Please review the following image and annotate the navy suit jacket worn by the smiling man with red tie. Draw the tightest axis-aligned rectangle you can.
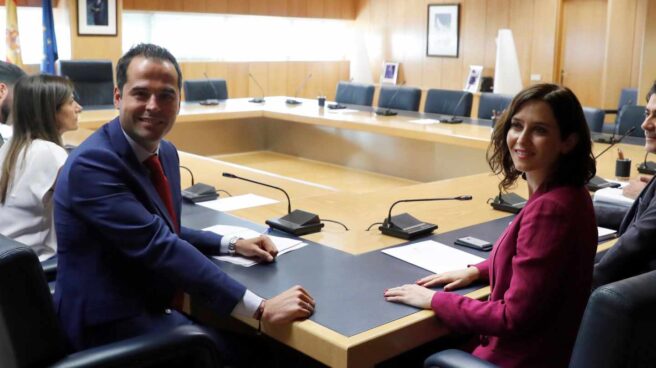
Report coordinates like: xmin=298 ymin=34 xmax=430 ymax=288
xmin=54 ymin=118 xmax=246 ymax=349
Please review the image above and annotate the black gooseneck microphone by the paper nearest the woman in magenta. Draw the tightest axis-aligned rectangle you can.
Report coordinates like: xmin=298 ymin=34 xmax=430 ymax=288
xmin=378 ymin=195 xmax=472 ymax=240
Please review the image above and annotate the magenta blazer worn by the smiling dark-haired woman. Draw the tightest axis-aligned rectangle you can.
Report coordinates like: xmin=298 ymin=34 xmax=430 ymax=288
xmin=431 ymin=186 xmax=597 ymax=367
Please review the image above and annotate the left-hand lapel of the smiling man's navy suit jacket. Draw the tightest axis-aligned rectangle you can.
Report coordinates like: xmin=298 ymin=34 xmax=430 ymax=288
xmin=108 ymin=118 xmax=176 ymax=231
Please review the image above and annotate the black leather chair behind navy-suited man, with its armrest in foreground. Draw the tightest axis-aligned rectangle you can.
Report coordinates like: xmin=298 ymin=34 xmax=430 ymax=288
xmin=0 ymin=235 xmax=221 ymax=368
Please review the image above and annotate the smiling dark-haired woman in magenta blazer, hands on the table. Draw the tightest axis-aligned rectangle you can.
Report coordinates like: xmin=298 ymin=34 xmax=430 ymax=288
xmin=385 ymin=84 xmax=597 ymax=367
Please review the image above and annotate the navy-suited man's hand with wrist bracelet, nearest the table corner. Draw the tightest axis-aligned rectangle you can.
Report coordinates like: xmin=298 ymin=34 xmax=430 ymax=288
xmin=262 ymin=285 xmax=315 ymax=324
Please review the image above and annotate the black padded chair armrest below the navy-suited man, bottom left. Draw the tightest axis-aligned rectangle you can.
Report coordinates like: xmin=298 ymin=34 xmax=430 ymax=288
xmin=52 ymin=325 xmax=221 ymax=368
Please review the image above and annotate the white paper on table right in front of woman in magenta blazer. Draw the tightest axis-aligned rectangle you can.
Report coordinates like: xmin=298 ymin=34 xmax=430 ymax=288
xmin=381 ymin=240 xmax=485 ymax=273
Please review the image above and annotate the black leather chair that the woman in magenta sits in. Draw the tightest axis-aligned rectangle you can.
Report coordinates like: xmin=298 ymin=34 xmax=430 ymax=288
xmin=424 ymin=271 xmax=656 ymax=368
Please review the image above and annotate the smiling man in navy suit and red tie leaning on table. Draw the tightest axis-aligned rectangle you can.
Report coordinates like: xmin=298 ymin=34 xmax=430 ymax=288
xmin=55 ymin=44 xmax=314 ymax=356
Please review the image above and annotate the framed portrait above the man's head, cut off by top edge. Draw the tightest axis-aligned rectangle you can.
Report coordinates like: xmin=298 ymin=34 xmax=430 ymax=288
xmin=77 ymin=0 xmax=117 ymax=36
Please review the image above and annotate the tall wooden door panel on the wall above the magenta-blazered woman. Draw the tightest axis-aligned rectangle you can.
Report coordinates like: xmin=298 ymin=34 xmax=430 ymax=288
xmin=560 ymin=0 xmax=608 ymax=107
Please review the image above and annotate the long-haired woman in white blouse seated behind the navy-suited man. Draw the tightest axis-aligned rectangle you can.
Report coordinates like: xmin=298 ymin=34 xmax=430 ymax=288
xmin=0 ymin=75 xmax=82 ymax=261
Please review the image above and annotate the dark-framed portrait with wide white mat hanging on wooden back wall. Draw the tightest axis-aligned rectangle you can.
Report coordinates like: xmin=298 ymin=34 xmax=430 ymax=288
xmin=426 ymin=4 xmax=460 ymax=57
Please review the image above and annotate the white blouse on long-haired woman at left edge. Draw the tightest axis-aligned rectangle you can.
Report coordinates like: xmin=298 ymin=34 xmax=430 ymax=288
xmin=0 ymin=139 xmax=68 ymax=261
